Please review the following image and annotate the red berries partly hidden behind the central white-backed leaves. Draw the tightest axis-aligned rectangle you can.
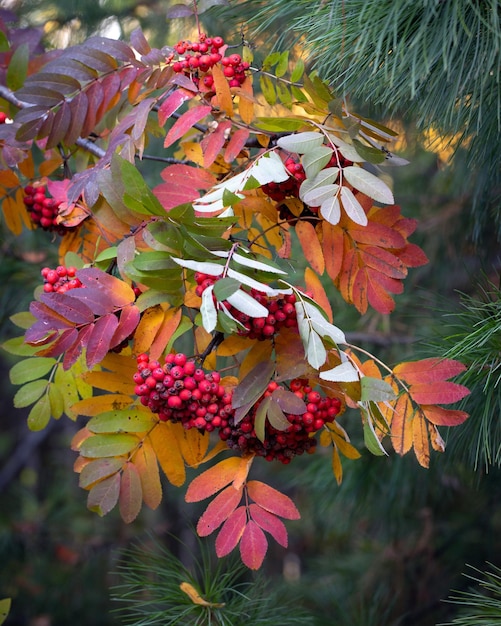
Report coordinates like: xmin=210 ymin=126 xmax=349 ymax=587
xmin=195 ymin=272 xmax=297 ymax=340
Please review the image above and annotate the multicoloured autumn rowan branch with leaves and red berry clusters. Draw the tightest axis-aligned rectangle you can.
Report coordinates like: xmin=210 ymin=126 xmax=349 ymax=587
xmin=0 ymin=9 xmax=468 ymax=569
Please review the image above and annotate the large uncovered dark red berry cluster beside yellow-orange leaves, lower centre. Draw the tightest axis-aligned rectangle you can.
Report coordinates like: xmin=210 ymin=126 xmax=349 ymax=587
xmin=134 ymin=352 xmax=233 ymax=432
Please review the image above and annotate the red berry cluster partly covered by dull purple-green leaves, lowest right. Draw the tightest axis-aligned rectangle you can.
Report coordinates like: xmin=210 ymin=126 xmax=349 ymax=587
xmin=219 ymin=379 xmax=341 ymax=464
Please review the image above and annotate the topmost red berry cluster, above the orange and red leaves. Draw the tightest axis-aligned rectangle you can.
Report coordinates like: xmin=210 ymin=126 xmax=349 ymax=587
xmin=170 ymin=33 xmax=250 ymax=89
